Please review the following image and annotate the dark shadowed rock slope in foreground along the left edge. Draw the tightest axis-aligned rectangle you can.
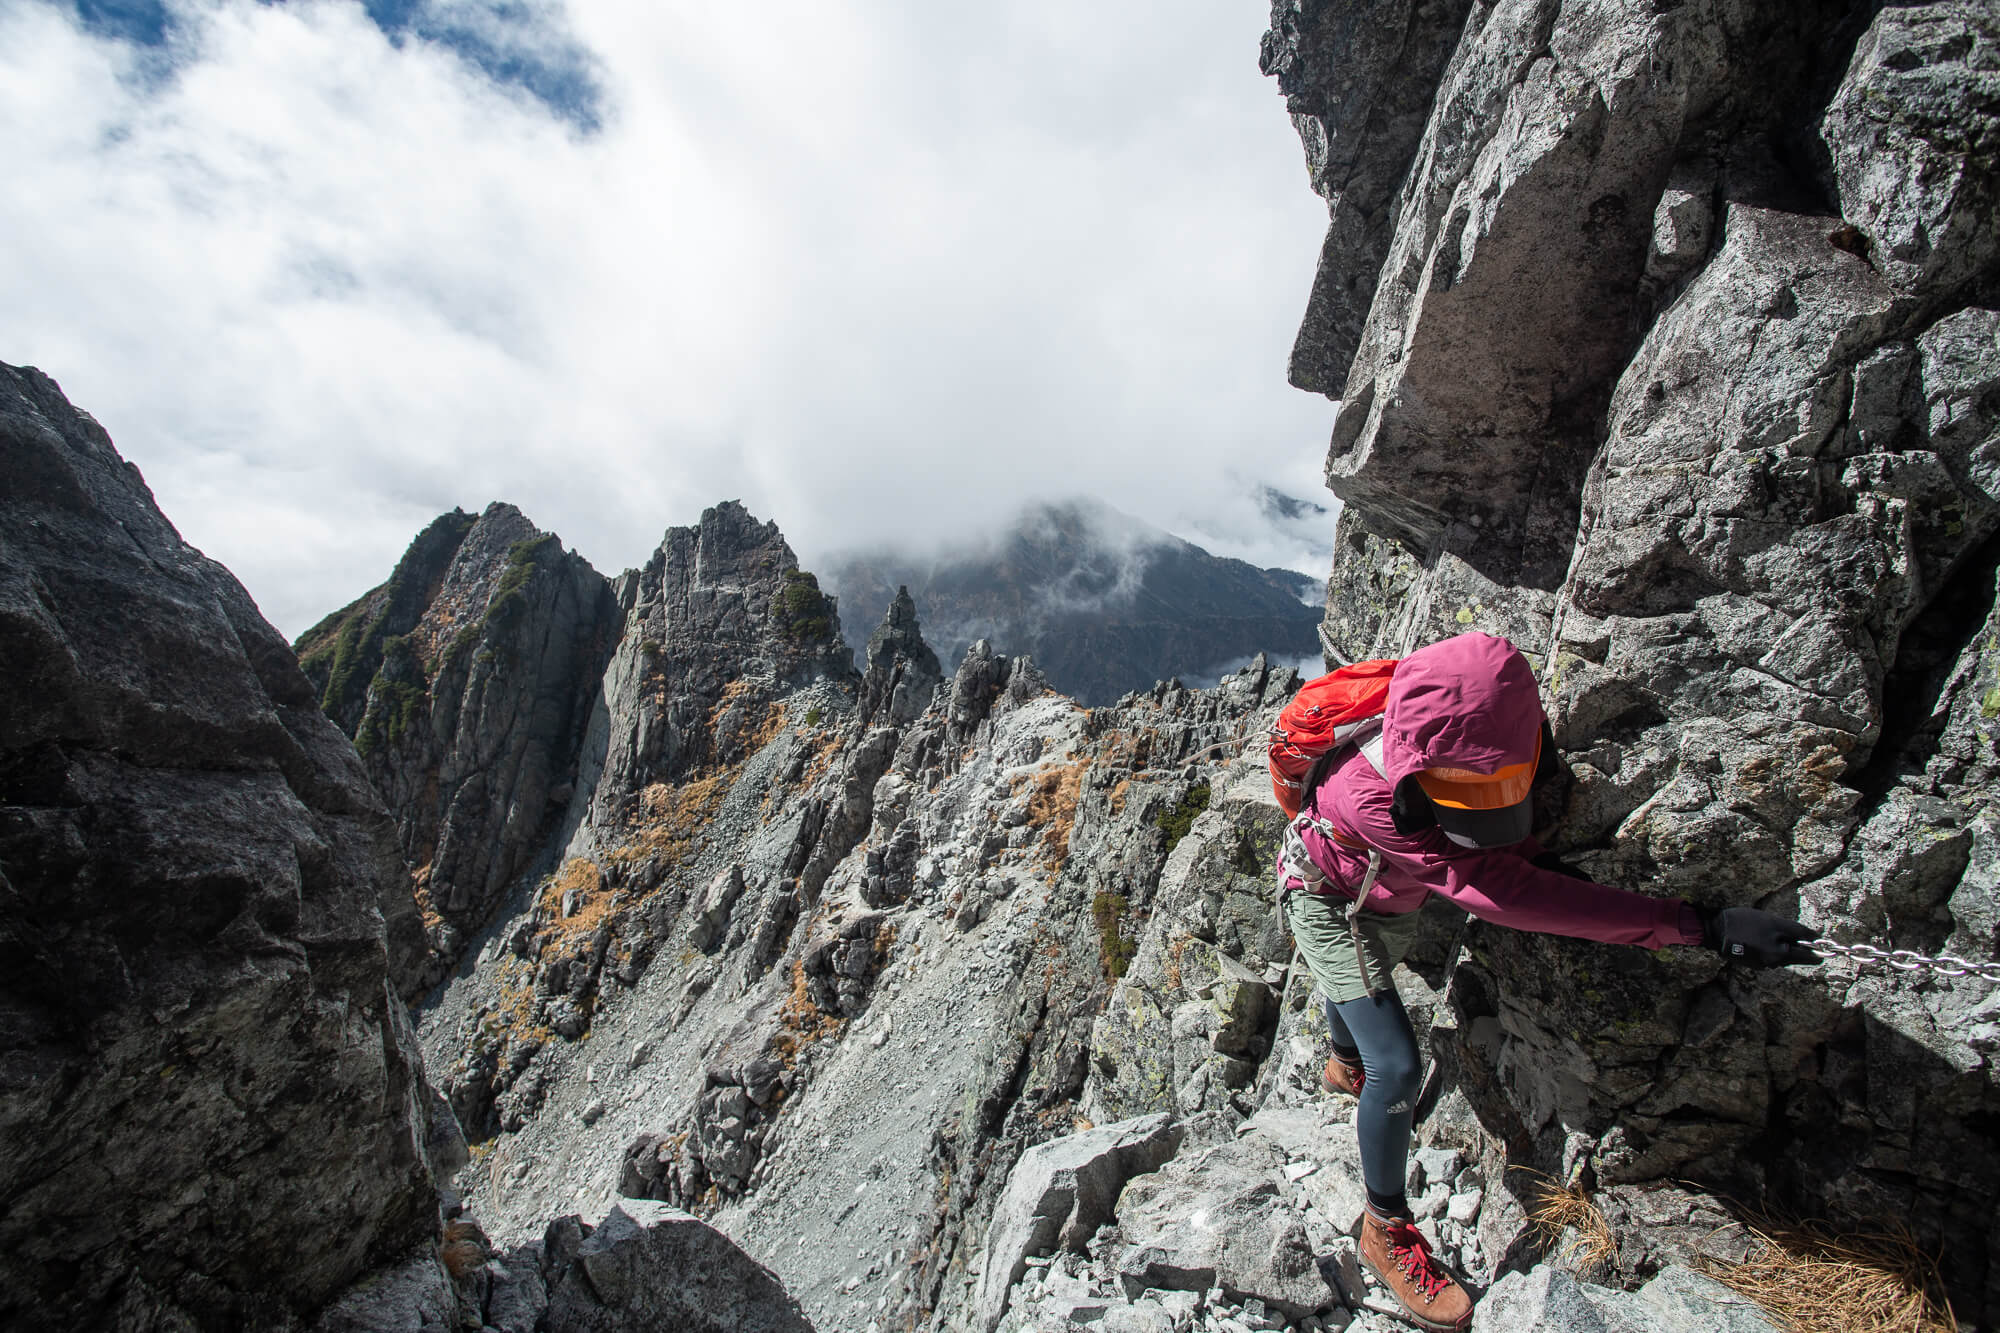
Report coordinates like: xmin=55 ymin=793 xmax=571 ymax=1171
xmin=0 ymin=366 xmax=438 ymax=1329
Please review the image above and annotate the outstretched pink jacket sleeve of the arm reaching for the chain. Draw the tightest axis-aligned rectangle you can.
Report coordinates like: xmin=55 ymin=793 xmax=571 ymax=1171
xmin=1348 ymin=756 xmax=1702 ymax=949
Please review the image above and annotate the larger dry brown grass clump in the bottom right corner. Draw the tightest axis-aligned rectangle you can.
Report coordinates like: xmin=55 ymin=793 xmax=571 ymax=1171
xmin=1702 ymin=1223 xmax=1958 ymax=1333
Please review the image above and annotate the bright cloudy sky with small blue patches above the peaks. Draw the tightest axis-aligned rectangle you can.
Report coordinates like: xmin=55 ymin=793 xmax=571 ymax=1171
xmin=0 ymin=0 xmax=1332 ymax=634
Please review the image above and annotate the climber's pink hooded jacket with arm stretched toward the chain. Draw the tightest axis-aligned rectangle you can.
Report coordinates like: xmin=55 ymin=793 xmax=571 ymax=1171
xmin=1288 ymin=634 xmax=1702 ymax=949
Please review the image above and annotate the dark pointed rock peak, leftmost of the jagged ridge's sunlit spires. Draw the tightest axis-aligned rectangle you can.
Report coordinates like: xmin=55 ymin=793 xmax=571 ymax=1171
xmin=296 ymin=504 xmax=620 ymax=981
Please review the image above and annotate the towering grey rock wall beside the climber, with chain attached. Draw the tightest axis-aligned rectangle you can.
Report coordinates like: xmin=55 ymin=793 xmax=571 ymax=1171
xmin=1264 ymin=0 xmax=2000 ymax=1313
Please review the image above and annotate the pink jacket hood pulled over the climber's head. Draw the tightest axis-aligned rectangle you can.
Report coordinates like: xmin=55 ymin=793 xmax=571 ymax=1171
xmin=1382 ymin=632 xmax=1542 ymax=787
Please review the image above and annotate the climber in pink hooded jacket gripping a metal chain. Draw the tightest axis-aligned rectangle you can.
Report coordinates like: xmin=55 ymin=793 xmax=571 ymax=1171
xmin=1278 ymin=634 xmax=1818 ymax=1331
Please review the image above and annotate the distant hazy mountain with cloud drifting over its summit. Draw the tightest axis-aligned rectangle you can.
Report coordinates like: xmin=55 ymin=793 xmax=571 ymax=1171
xmin=822 ymin=500 xmax=1320 ymax=705
